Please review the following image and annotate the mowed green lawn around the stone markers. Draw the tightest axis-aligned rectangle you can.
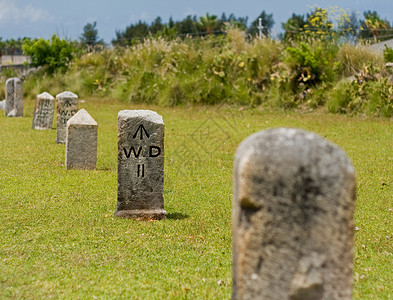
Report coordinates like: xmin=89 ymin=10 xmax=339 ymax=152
xmin=0 ymin=99 xmax=393 ymax=299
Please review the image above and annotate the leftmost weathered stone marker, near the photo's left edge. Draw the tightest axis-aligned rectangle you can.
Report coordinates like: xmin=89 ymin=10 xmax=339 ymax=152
xmin=5 ymin=78 xmax=23 ymax=117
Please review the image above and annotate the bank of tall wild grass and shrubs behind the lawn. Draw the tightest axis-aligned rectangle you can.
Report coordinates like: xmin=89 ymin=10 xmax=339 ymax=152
xmin=0 ymin=29 xmax=392 ymax=116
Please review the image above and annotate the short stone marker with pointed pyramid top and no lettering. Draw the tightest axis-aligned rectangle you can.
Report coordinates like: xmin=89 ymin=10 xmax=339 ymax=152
xmin=65 ymin=109 xmax=97 ymax=170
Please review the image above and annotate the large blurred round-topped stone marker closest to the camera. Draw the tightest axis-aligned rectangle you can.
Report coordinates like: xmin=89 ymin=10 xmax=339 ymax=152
xmin=232 ymin=128 xmax=356 ymax=300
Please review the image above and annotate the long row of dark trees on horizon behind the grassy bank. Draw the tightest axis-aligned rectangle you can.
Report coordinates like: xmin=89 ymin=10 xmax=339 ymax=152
xmin=112 ymin=7 xmax=393 ymax=46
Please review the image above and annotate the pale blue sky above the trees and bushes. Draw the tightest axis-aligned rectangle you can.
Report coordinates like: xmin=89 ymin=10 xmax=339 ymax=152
xmin=0 ymin=0 xmax=393 ymax=43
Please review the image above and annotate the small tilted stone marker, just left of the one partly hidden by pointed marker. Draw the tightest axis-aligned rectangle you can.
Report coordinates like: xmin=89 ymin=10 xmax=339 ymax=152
xmin=33 ymin=92 xmax=55 ymax=130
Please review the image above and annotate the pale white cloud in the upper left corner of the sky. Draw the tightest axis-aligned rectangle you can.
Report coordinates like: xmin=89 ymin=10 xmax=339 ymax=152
xmin=0 ymin=0 xmax=53 ymax=23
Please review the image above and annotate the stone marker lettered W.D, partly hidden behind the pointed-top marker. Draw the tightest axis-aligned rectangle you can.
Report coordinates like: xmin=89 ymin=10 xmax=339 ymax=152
xmin=56 ymin=92 xmax=78 ymax=144
